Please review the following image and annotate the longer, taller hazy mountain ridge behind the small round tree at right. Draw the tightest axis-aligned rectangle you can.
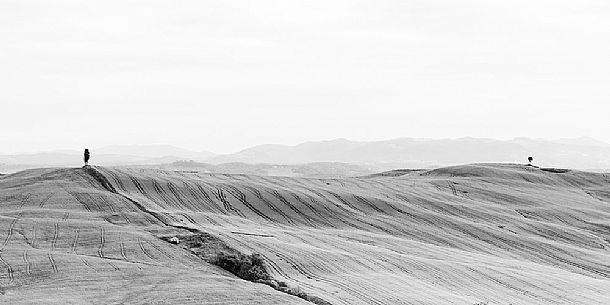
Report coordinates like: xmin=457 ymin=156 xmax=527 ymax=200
xmin=207 ymin=138 xmax=610 ymax=169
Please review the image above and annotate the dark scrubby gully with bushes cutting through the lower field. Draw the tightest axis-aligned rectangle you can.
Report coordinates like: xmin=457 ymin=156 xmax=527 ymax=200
xmin=159 ymin=232 xmax=332 ymax=305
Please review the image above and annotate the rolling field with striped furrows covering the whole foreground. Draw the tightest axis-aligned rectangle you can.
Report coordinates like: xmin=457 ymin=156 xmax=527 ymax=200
xmin=0 ymin=164 xmax=610 ymax=305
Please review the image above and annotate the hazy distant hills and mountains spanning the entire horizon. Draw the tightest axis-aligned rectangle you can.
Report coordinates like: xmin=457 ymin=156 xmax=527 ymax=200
xmin=0 ymin=137 xmax=610 ymax=172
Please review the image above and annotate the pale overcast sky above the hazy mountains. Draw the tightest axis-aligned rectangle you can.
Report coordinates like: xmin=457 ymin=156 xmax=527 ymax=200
xmin=0 ymin=0 xmax=610 ymax=153
